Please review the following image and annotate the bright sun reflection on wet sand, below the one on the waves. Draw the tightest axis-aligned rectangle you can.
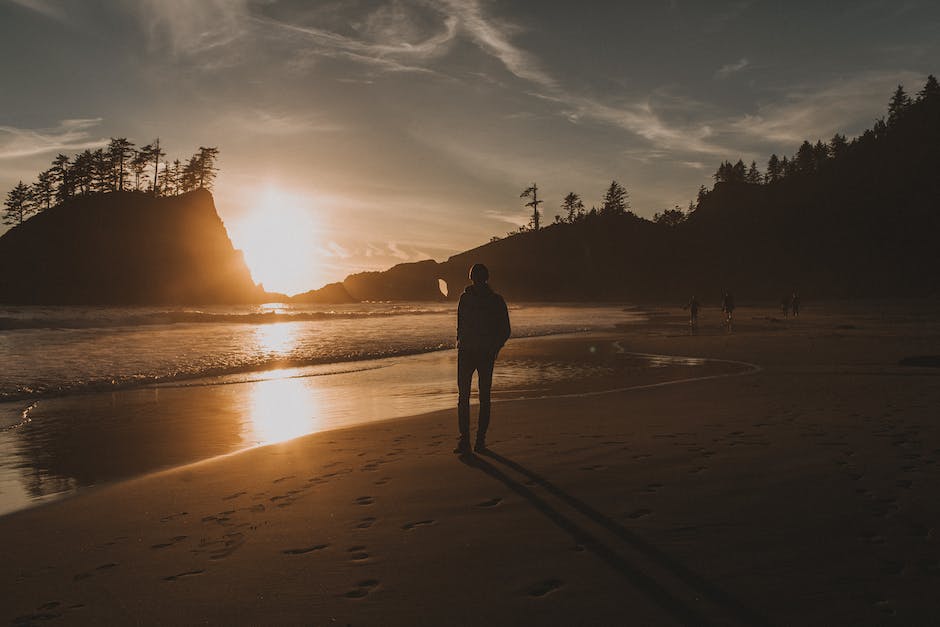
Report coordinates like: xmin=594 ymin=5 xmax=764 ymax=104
xmin=245 ymin=372 xmax=320 ymax=444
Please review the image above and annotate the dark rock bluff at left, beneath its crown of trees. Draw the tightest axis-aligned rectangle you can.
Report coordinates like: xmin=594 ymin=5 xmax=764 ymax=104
xmin=0 ymin=190 xmax=264 ymax=305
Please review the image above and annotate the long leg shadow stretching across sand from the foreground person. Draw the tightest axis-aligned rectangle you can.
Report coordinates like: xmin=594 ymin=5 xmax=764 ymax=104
xmin=460 ymin=450 xmax=771 ymax=625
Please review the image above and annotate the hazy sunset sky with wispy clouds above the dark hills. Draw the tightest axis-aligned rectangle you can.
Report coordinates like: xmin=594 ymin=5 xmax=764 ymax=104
xmin=0 ymin=0 xmax=940 ymax=293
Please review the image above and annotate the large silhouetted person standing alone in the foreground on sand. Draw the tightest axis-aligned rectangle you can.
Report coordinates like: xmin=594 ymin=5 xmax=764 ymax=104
xmin=454 ymin=263 xmax=511 ymax=454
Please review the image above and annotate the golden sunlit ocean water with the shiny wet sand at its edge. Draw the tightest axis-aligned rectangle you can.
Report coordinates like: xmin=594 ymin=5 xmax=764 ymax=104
xmin=0 ymin=303 xmax=644 ymax=514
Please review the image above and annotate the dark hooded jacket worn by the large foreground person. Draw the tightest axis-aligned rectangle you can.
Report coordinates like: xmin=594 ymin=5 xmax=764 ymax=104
xmin=457 ymin=285 xmax=512 ymax=358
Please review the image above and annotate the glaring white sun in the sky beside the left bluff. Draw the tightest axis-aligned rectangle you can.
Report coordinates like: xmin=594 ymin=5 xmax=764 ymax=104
xmin=229 ymin=186 xmax=322 ymax=294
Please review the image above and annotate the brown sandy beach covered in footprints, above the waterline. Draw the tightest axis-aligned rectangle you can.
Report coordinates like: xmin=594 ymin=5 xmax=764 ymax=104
xmin=0 ymin=303 xmax=940 ymax=625
